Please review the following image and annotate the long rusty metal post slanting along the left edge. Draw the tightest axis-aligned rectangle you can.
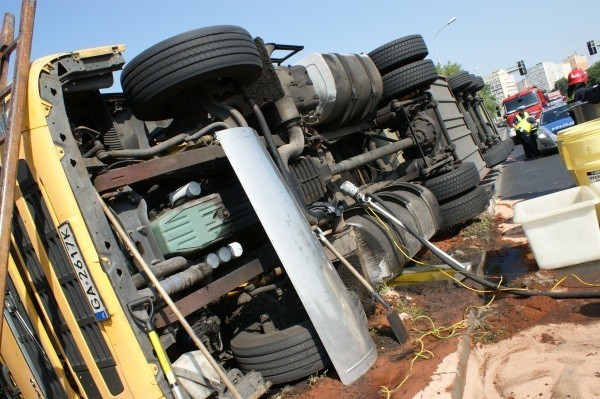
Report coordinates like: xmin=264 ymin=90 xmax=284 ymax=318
xmin=0 ymin=0 xmax=36 ymax=340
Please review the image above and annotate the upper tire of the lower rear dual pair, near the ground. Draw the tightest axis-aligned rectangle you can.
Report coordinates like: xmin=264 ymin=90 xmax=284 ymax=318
xmin=423 ymin=162 xmax=481 ymax=202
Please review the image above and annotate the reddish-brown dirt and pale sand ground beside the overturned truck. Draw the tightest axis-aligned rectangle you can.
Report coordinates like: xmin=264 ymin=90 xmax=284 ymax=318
xmin=268 ymin=201 xmax=600 ymax=399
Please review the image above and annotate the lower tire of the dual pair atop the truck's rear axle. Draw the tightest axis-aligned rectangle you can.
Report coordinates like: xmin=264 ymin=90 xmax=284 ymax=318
xmin=382 ymin=60 xmax=439 ymax=104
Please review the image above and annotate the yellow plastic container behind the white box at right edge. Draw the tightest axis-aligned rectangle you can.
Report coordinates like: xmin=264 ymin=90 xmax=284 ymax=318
xmin=557 ymin=119 xmax=600 ymax=219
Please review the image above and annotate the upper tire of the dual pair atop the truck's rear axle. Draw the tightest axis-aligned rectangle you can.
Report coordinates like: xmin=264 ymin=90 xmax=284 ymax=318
xmin=367 ymin=35 xmax=429 ymax=75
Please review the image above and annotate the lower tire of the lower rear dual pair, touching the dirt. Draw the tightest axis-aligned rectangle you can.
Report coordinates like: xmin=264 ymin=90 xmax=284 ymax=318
xmin=440 ymin=186 xmax=490 ymax=230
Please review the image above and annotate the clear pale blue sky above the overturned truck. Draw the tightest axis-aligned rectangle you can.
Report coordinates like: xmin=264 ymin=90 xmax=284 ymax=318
xmin=0 ymin=0 xmax=600 ymax=87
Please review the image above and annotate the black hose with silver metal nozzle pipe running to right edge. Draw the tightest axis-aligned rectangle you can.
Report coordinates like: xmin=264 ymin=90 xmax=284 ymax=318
xmin=341 ymin=182 xmax=600 ymax=299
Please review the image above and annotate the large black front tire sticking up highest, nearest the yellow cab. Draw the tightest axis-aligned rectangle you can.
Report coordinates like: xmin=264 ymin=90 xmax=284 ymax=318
xmin=121 ymin=25 xmax=262 ymax=120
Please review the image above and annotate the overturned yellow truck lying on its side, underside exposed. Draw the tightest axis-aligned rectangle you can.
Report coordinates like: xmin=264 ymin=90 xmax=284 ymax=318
xmin=0 ymin=10 xmax=502 ymax=398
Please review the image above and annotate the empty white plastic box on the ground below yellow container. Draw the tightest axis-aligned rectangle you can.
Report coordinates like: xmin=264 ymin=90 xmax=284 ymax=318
xmin=513 ymin=186 xmax=600 ymax=269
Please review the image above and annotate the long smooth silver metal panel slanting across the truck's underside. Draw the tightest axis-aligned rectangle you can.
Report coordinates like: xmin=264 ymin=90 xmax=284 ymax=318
xmin=217 ymin=128 xmax=377 ymax=385
